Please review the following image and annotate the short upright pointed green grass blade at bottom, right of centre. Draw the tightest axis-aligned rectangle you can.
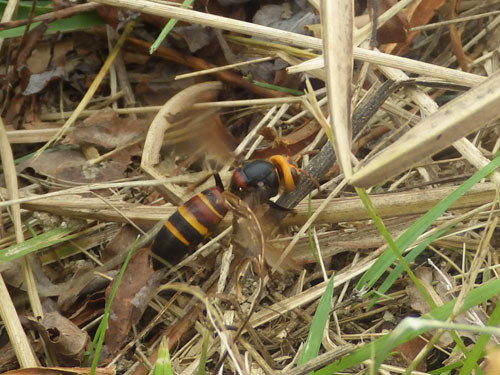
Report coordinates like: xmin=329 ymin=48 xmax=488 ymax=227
xmin=297 ymin=275 xmax=334 ymax=365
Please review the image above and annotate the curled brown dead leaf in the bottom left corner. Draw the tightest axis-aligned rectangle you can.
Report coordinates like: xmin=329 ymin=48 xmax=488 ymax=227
xmin=25 ymin=311 xmax=90 ymax=365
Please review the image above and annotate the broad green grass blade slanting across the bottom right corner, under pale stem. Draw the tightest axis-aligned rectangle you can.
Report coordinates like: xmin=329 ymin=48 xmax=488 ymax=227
xmin=315 ymin=279 xmax=500 ymax=375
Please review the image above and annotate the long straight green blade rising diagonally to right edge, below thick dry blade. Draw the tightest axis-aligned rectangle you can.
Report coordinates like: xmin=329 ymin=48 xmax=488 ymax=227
xmin=356 ymin=151 xmax=500 ymax=289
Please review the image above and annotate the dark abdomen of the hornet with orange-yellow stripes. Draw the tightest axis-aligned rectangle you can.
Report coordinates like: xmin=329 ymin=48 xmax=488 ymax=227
xmin=152 ymin=187 xmax=227 ymax=268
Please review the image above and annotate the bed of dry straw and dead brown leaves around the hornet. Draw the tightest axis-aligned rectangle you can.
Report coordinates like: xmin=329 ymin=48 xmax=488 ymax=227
xmin=0 ymin=0 xmax=500 ymax=375
